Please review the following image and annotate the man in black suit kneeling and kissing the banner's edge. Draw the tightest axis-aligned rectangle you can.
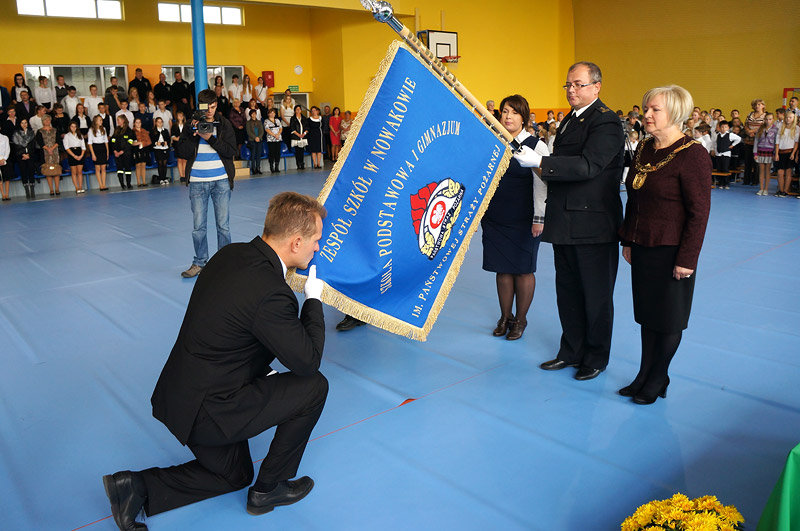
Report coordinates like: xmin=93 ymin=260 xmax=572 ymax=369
xmin=103 ymin=192 xmax=328 ymax=530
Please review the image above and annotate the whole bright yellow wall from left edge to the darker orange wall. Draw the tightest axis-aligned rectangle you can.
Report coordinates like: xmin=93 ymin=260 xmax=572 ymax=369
xmin=0 ymin=0 xmax=574 ymax=115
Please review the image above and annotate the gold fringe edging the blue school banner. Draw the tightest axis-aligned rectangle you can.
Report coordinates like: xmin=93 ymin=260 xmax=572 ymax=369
xmin=286 ymin=41 xmax=511 ymax=341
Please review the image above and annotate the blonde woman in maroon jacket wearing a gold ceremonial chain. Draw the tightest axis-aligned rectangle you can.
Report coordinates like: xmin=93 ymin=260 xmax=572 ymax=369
xmin=620 ymin=85 xmax=711 ymax=404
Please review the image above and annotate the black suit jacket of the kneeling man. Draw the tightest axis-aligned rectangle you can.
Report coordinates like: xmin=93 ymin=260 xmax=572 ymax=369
xmin=151 ymin=237 xmax=325 ymax=444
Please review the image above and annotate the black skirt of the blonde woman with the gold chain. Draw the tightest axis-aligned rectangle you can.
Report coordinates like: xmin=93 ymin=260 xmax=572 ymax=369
xmin=631 ymin=244 xmax=696 ymax=333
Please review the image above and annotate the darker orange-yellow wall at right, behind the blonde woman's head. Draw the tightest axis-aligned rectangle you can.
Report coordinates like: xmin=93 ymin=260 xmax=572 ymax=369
xmin=573 ymin=0 xmax=800 ymax=116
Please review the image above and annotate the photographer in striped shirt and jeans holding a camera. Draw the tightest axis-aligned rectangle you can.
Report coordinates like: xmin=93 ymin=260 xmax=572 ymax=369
xmin=181 ymin=89 xmax=236 ymax=278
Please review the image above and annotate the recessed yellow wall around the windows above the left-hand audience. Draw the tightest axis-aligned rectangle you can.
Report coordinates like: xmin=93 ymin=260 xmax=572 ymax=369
xmin=0 ymin=0 xmax=313 ymax=91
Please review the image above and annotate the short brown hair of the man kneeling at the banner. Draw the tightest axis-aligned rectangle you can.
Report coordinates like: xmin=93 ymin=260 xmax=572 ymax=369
xmin=264 ymin=192 xmax=328 ymax=238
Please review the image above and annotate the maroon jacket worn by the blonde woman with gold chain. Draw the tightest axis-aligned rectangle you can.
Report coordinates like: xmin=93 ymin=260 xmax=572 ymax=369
xmin=619 ymin=137 xmax=711 ymax=269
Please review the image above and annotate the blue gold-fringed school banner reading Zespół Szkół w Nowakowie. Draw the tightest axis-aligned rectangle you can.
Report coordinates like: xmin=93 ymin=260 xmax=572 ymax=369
xmin=288 ymin=41 xmax=511 ymax=341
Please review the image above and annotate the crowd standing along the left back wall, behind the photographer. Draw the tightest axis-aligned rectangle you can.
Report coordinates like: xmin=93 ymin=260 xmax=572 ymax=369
xmin=0 ymin=68 xmax=352 ymax=201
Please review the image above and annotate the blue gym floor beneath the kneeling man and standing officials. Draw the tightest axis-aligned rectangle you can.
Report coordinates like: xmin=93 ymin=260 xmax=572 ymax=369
xmin=0 ymin=171 xmax=800 ymax=531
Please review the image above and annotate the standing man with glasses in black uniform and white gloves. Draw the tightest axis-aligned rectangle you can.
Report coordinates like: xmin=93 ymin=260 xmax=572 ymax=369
xmin=515 ymin=62 xmax=624 ymax=380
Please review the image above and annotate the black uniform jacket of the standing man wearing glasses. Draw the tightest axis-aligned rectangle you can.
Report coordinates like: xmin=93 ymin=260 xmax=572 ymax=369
xmin=541 ymin=99 xmax=625 ymax=245
